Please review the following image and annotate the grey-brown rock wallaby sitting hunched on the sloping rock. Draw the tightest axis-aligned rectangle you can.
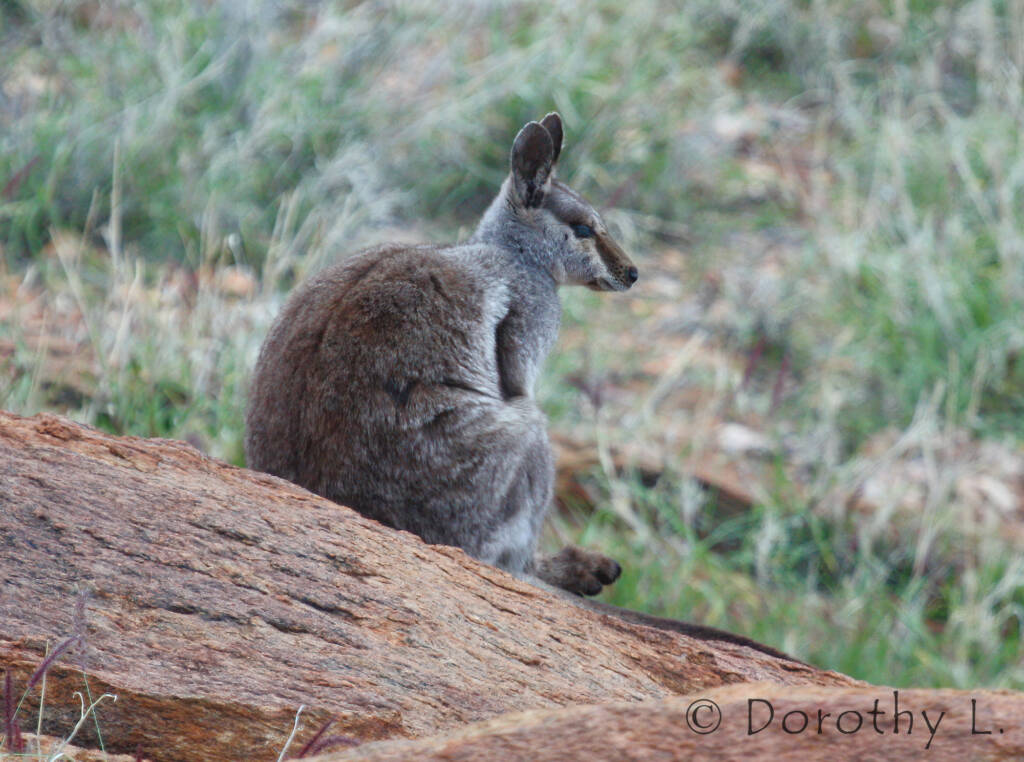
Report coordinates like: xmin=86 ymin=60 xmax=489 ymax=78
xmin=246 ymin=114 xmax=638 ymax=595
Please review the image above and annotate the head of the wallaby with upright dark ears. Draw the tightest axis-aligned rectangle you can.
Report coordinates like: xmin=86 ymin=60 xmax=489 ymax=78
xmin=474 ymin=113 xmax=639 ymax=291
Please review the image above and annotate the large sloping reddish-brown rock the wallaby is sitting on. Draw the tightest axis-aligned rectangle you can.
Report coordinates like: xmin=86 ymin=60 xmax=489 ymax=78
xmin=0 ymin=413 xmax=857 ymax=761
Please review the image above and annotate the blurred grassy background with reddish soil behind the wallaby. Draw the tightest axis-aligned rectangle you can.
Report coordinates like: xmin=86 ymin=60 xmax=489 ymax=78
xmin=0 ymin=0 xmax=1024 ymax=689
